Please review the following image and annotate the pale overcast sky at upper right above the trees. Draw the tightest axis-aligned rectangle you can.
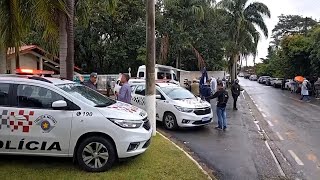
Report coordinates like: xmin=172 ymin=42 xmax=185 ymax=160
xmin=248 ymin=0 xmax=320 ymax=65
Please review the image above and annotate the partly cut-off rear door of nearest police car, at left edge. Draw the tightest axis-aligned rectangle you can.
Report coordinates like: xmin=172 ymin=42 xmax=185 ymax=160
xmin=0 ymin=83 xmax=12 ymax=152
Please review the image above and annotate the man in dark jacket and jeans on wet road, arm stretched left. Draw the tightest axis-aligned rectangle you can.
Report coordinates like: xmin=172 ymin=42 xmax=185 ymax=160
xmin=206 ymin=81 xmax=229 ymax=131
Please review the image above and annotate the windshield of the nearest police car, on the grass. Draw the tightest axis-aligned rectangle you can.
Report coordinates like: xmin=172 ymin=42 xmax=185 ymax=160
xmin=58 ymin=84 xmax=116 ymax=107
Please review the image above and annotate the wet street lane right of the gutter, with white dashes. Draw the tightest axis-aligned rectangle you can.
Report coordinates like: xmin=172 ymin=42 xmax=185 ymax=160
xmin=240 ymin=79 xmax=320 ymax=180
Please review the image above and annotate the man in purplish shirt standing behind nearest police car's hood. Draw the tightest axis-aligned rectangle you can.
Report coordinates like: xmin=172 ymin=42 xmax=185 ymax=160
xmin=117 ymin=74 xmax=131 ymax=104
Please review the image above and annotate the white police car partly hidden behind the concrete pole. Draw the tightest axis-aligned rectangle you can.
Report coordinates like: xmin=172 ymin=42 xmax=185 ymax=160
xmin=131 ymin=83 xmax=213 ymax=130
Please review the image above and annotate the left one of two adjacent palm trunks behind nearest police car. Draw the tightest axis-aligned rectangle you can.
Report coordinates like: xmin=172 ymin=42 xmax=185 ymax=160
xmin=59 ymin=12 xmax=68 ymax=78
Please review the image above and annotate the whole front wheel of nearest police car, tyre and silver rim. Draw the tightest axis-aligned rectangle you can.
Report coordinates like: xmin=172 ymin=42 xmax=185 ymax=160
xmin=77 ymin=136 xmax=116 ymax=172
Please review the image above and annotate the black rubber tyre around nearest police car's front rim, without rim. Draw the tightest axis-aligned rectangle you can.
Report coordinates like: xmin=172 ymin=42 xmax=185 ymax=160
xmin=77 ymin=136 xmax=116 ymax=172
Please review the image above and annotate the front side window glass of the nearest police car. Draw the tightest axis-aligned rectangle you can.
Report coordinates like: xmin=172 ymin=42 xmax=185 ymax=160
xmin=17 ymin=85 xmax=64 ymax=109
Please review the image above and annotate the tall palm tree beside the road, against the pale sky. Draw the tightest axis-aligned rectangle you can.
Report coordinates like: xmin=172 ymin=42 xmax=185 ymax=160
xmin=217 ymin=0 xmax=271 ymax=81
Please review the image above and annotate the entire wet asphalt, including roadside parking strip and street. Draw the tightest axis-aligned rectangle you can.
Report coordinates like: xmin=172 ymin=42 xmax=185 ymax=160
xmin=160 ymin=79 xmax=320 ymax=180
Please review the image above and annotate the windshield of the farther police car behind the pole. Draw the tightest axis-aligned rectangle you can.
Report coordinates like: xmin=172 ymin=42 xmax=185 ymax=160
xmin=161 ymin=87 xmax=196 ymax=100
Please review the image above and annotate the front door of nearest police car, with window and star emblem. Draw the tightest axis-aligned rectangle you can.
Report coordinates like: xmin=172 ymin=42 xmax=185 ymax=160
xmin=10 ymin=84 xmax=73 ymax=156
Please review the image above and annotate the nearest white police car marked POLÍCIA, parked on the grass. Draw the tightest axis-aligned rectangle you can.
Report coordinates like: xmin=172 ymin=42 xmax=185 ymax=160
xmin=0 ymin=70 xmax=152 ymax=172
